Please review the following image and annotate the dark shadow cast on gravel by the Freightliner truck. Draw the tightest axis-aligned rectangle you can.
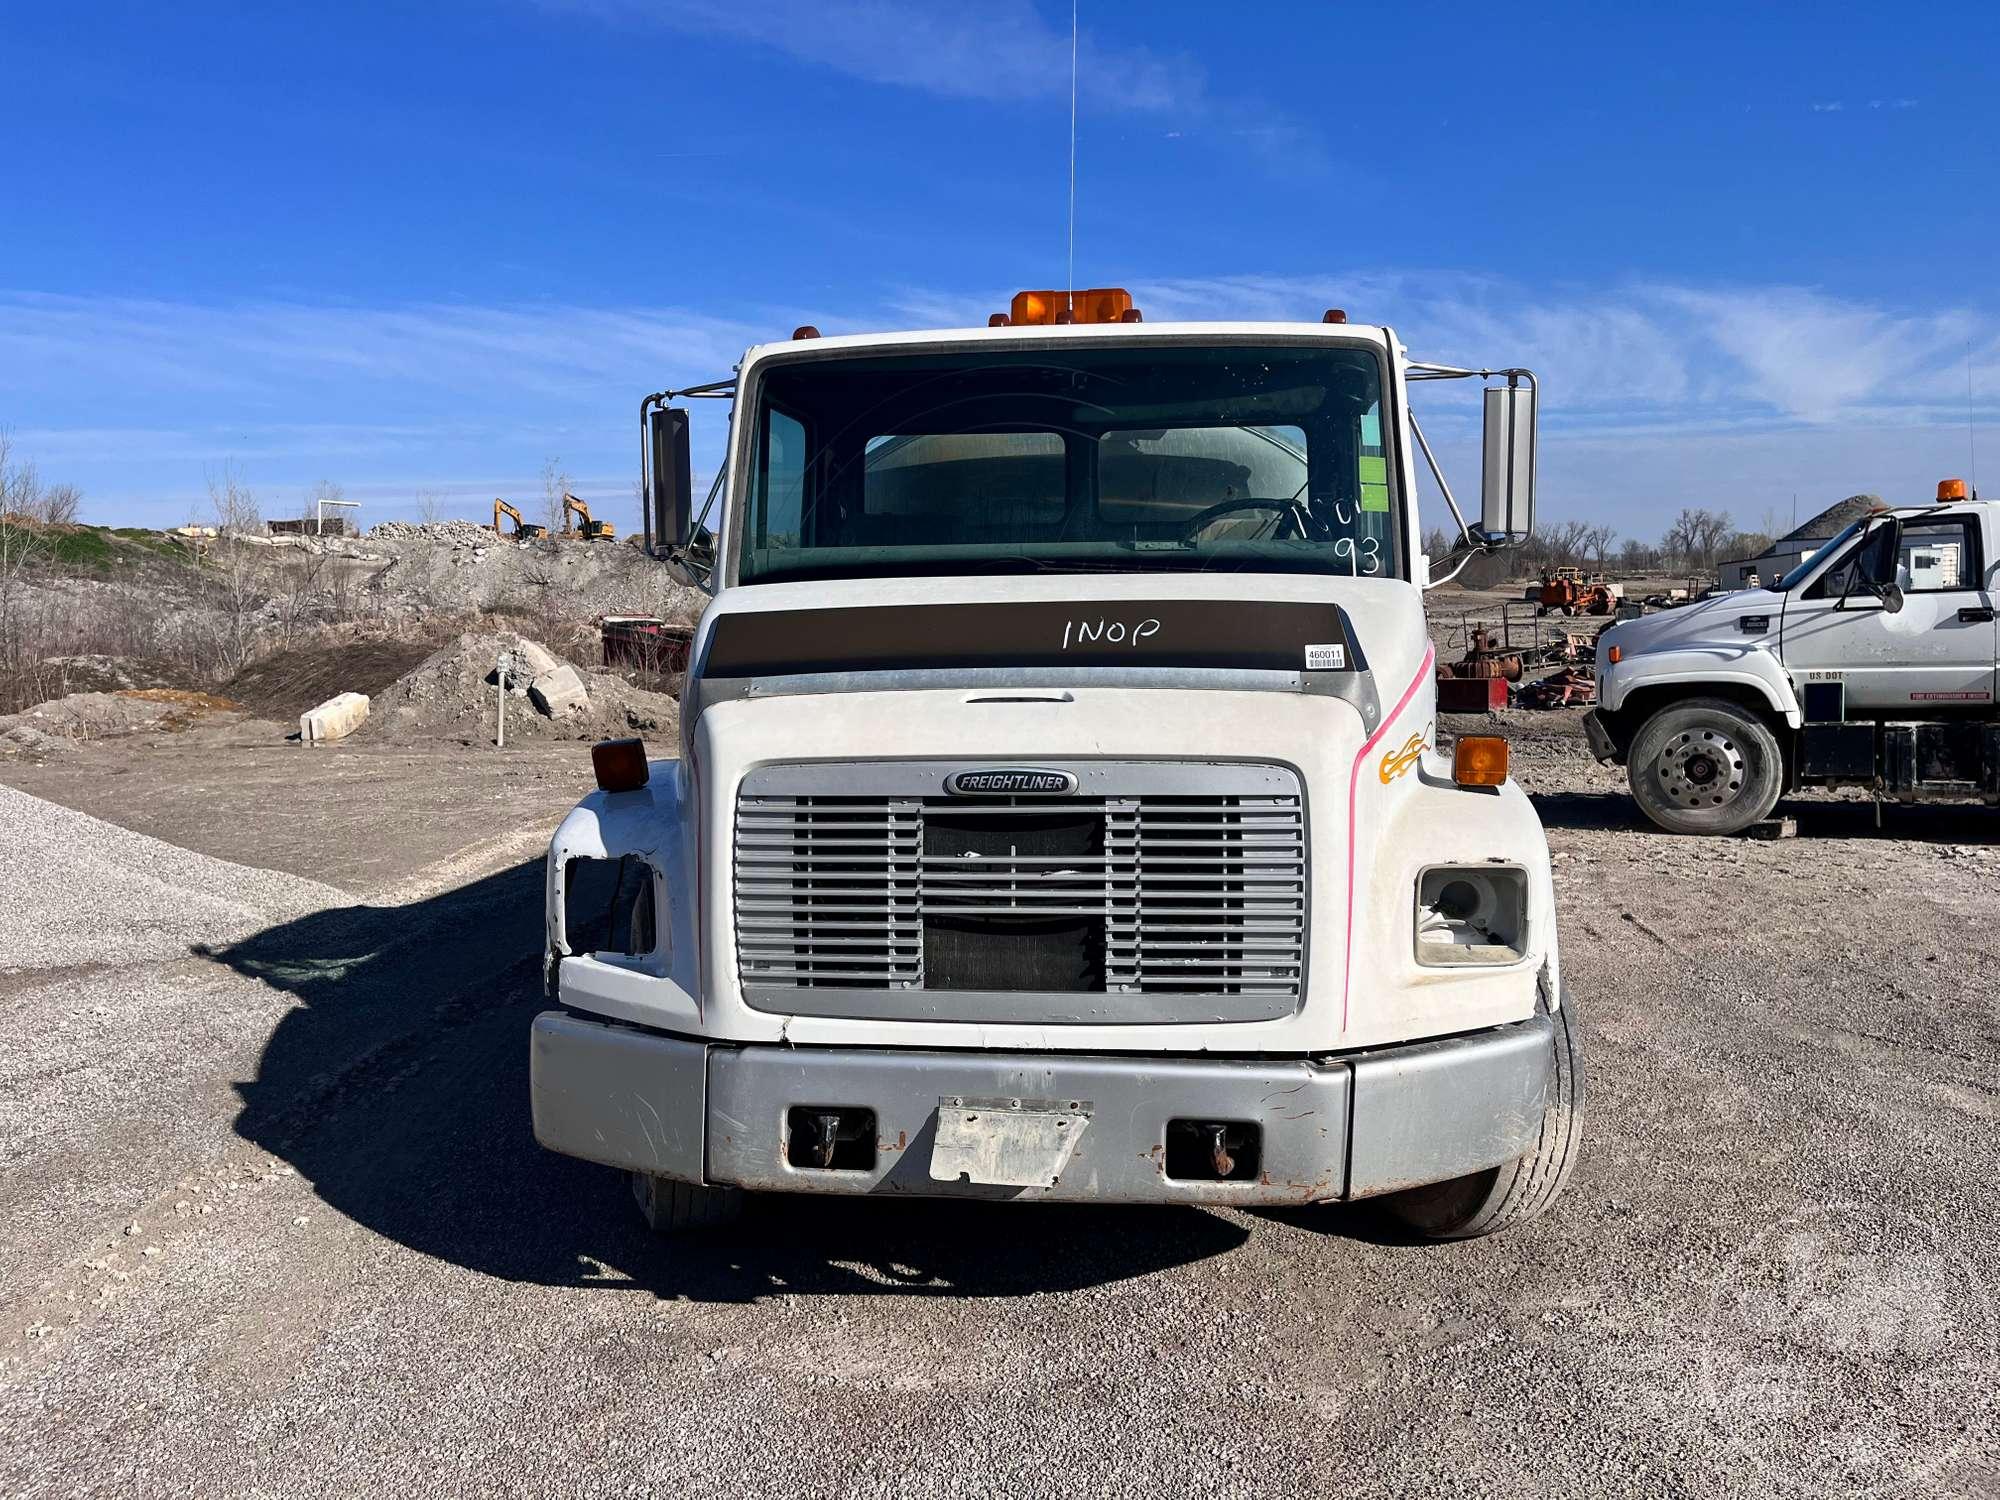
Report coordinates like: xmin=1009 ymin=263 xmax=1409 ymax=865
xmin=198 ymin=860 xmax=1264 ymax=1302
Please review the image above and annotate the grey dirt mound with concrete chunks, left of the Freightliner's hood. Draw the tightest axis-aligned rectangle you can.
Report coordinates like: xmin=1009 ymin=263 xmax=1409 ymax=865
xmin=356 ymin=630 xmax=680 ymax=744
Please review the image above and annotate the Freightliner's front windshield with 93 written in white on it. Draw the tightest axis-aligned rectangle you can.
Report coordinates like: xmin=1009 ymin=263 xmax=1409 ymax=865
xmin=738 ymin=344 xmax=1404 ymax=584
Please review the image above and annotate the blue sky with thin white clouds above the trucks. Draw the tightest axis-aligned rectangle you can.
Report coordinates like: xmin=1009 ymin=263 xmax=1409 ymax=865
xmin=0 ymin=0 xmax=2000 ymax=538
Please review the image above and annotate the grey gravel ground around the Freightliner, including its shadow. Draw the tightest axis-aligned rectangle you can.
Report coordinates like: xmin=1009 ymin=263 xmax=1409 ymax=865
xmin=0 ymin=736 xmax=2000 ymax=1496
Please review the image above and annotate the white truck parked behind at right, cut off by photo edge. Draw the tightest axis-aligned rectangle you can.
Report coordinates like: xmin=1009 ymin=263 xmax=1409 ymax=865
xmin=1584 ymin=480 xmax=2000 ymax=834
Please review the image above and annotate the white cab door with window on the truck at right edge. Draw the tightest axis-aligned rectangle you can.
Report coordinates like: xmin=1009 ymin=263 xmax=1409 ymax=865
xmin=1778 ymin=510 xmax=1996 ymax=718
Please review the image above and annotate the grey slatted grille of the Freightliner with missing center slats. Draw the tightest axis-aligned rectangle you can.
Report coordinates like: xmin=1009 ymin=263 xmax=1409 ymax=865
xmin=734 ymin=772 xmax=1306 ymax=1020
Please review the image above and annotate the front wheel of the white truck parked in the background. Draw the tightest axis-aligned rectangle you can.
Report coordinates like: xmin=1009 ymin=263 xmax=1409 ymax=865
xmin=1626 ymin=698 xmax=1784 ymax=834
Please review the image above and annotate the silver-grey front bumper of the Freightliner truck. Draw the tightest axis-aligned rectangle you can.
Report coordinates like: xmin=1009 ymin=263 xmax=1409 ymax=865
xmin=530 ymin=1010 xmax=1554 ymax=1204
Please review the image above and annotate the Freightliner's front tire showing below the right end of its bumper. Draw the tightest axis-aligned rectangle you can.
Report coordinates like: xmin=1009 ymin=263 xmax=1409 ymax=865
xmin=1382 ymin=994 xmax=1584 ymax=1240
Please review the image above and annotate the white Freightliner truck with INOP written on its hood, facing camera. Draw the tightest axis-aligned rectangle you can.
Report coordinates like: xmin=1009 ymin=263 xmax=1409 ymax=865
xmin=532 ymin=292 xmax=1582 ymax=1236
